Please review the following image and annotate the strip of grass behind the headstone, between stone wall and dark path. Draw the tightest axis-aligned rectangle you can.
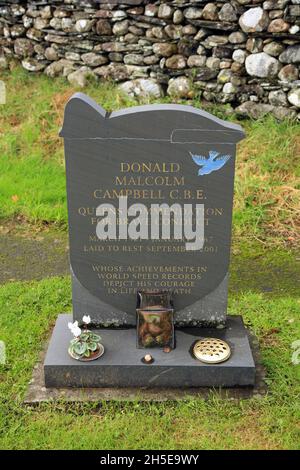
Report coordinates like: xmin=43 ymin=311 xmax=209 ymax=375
xmin=0 ymin=67 xmax=300 ymax=245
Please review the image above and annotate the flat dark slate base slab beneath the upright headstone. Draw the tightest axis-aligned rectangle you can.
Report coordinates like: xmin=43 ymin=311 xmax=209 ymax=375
xmin=44 ymin=314 xmax=255 ymax=388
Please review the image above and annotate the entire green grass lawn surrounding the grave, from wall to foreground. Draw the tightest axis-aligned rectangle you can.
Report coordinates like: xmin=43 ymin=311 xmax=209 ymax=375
xmin=0 ymin=67 xmax=300 ymax=449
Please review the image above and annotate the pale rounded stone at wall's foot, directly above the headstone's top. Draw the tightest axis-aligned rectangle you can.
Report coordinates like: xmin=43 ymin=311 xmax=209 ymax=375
xmin=119 ymin=78 xmax=164 ymax=100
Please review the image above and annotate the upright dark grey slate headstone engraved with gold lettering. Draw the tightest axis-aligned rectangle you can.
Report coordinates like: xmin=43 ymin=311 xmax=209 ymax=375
xmin=60 ymin=93 xmax=244 ymax=326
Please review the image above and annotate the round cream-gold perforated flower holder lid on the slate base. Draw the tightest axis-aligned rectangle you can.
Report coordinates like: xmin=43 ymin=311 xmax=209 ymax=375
xmin=193 ymin=338 xmax=231 ymax=364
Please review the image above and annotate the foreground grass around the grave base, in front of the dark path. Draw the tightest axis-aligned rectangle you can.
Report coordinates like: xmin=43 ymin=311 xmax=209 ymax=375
xmin=0 ymin=278 xmax=300 ymax=449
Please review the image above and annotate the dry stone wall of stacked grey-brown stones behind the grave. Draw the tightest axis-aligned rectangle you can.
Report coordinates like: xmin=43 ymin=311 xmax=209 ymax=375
xmin=0 ymin=0 xmax=300 ymax=118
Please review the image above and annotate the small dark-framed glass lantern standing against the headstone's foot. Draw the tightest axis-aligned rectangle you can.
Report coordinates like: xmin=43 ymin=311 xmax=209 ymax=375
xmin=136 ymin=291 xmax=174 ymax=349
